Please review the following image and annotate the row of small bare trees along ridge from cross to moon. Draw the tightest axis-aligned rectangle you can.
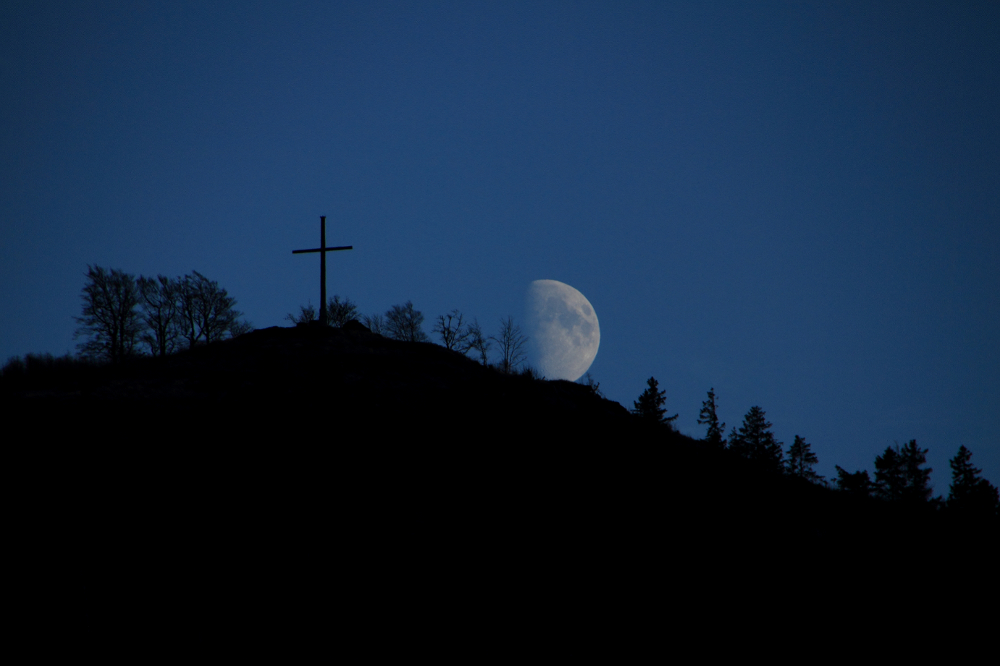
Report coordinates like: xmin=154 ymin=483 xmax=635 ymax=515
xmin=286 ymin=296 xmax=538 ymax=376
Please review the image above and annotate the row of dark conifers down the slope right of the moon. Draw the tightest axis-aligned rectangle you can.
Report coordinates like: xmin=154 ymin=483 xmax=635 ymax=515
xmin=632 ymin=377 xmax=1000 ymax=519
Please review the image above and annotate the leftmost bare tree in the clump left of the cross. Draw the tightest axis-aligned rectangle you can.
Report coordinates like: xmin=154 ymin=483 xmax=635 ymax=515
xmin=74 ymin=265 xmax=143 ymax=363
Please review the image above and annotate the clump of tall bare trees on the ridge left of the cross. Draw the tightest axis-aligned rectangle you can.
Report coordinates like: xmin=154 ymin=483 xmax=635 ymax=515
xmin=74 ymin=266 xmax=253 ymax=363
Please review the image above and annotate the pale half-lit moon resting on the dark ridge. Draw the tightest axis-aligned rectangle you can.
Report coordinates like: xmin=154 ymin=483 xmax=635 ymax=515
xmin=525 ymin=280 xmax=601 ymax=382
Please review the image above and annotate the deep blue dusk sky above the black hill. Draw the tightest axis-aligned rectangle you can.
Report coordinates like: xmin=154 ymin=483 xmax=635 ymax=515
xmin=0 ymin=0 xmax=1000 ymax=488
